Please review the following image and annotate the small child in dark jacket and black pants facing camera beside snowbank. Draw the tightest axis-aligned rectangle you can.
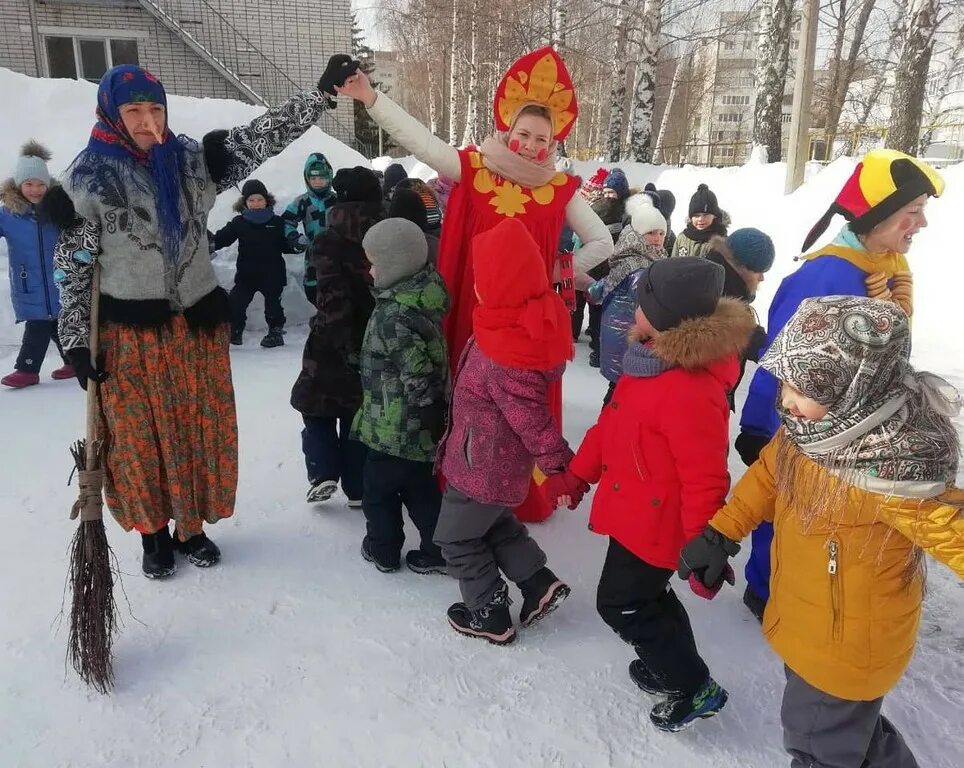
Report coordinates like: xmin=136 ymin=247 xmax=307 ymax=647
xmin=214 ymin=179 xmax=299 ymax=347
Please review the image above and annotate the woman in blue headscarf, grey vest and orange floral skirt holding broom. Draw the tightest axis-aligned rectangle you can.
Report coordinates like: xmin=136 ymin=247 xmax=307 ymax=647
xmin=45 ymin=57 xmax=353 ymax=578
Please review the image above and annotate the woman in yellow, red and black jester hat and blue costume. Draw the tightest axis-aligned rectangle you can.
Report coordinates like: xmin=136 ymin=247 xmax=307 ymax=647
xmin=736 ymin=149 xmax=944 ymax=620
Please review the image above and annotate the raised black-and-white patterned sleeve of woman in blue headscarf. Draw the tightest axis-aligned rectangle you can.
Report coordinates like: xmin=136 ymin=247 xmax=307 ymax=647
xmin=203 ymin=89 xmax=328 ymax=192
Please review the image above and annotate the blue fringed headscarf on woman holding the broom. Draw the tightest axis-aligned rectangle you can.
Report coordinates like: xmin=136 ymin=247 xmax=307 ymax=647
xmin=71 ymin=64 xmax=184 ymax=264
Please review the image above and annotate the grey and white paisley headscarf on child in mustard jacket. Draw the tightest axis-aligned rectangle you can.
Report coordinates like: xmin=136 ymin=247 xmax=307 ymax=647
xmin=760 ymin=296 xmax=961 ymax=498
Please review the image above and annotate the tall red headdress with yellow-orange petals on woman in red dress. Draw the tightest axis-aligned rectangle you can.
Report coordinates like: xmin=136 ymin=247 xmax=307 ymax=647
xmin=495 ymin=47 xmax=579 ymax=141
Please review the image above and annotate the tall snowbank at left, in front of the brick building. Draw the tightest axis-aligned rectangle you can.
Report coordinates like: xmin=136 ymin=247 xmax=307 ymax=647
xmin=0 ymin=68 xmax=368 ymax=344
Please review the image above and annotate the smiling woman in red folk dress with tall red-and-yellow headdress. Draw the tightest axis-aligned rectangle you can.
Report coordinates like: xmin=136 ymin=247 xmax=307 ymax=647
xmin=338 ymin=48 xmax=613 ymax=522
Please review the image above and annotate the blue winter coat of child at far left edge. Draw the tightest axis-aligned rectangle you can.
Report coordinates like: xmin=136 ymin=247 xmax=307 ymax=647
xmin=0 ymin=179 xmax=60 ymax=323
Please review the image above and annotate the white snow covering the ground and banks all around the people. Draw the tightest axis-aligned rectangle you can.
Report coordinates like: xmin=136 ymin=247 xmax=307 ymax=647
xmin=0 ymin=70 xmax=964 ymax=768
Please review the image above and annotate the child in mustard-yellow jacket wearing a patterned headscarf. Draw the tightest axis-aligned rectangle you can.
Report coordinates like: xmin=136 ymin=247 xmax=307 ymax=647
xmin=679 ymin=296 xmax=964 ymax=768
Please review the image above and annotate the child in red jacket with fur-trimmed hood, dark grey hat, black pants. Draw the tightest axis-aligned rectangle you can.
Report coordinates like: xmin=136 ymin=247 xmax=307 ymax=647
xmin=546 ymin=257 xmax=756 ymax=731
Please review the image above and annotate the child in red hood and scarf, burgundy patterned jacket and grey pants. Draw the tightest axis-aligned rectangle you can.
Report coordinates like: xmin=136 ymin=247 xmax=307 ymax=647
xmin=435 ymin=219 xmax=588 ymax=645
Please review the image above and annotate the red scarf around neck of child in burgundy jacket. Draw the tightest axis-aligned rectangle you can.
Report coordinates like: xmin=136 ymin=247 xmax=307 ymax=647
xmin=472 ymin=291 xmax=573 ymax=371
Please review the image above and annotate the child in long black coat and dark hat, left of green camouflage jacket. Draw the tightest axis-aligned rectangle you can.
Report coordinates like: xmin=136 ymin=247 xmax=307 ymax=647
xmin=291 ymin=166 xmax=382 ymax=508
